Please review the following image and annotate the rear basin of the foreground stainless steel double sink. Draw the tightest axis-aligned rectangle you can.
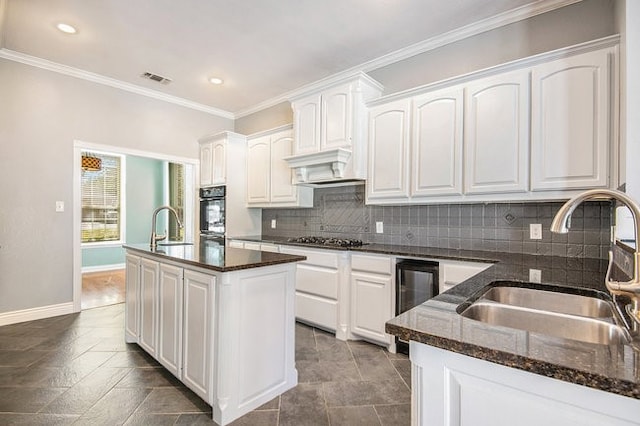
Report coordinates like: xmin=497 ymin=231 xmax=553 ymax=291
xmin=480 ymin=287 xmax=613 ymax=318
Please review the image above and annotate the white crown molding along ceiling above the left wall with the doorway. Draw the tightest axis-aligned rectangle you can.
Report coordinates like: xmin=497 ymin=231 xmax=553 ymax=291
xmin=0 ymin=48 xmax=236 ymax=120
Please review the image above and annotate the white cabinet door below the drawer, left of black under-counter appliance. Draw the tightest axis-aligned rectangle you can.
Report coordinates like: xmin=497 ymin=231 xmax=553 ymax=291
xmin=351 ymin=272 xmax=393 ymax=343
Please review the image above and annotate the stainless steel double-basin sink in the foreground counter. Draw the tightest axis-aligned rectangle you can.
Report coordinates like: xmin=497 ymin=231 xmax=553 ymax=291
xmin=461 ymin=287 xmax=630 ymax=345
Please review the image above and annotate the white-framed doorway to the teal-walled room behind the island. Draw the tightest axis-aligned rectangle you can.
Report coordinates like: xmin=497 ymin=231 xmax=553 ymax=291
xmin=73 ymin=141 xmax=198 ymax=312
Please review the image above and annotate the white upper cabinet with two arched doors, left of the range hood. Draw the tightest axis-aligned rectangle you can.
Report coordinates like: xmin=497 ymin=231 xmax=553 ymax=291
xmin=247 ymin=128 xmax=313 ymax=207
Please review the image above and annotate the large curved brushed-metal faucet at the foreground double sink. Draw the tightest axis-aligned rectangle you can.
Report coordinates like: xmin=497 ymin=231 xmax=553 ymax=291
xmin=550 ymin=189 xmax=640 ymax=331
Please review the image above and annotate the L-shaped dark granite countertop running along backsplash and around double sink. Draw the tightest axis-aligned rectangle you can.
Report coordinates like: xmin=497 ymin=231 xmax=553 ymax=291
xmin=232 ymin=236 xmax=640 ymax=399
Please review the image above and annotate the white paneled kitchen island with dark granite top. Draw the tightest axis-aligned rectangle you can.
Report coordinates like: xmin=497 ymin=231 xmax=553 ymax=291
xmin=124 ymin=244 xmax=305 ymax=425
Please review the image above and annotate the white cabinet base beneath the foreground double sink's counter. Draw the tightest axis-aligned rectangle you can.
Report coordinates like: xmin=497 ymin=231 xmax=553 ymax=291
xmin=410 ymin=341 xmax=640 ymax=426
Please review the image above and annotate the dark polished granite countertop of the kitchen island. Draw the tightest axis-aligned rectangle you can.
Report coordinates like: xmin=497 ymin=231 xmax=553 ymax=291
xmin=123 ymin=243 xmax=306 ymax=272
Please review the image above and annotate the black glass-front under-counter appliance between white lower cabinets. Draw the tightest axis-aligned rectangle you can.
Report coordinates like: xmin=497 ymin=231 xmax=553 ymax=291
xmin=396 ymin=259 xmax=439 ymax=354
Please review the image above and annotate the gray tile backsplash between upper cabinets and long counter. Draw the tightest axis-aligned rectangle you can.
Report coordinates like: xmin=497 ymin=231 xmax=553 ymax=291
xmin=262 ymin=185 xmax=612 ymax=258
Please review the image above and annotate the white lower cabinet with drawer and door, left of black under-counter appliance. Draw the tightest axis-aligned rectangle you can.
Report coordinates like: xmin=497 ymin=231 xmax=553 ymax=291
xmin=350 ymin=254 xmax=395 ymax=345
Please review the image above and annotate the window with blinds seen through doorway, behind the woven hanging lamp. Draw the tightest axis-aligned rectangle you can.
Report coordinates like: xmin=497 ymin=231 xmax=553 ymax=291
xmin=81 ymin=151 xmax=124 ymax=243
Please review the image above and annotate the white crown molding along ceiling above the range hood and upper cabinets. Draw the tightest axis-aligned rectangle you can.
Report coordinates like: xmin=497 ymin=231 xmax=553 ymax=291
xmin=235 ymin=0 xmax=582 ymax=118
